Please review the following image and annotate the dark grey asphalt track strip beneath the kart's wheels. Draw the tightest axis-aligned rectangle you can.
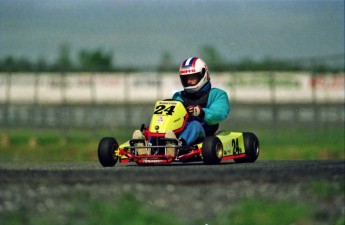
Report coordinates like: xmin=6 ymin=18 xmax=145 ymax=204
xmin=0 ymin=160 xmax=345 ymax=185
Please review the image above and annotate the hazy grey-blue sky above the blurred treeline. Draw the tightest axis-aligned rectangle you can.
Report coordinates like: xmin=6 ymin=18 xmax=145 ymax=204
xmin=0 ymin=0 xmax=344 ymax=67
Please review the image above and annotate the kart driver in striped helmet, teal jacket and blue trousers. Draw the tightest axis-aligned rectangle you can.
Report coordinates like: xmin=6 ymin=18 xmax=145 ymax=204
xmin=133 ymin=57 xmax=230 ymax=154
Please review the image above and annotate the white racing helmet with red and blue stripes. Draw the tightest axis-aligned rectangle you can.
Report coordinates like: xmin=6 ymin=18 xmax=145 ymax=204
xmin=179 ymin=57 xmax=210 ymax=93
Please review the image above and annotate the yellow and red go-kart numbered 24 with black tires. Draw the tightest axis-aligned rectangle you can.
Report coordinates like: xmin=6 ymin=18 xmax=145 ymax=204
xmin=98 ymin=99 xmax=259 ymax=167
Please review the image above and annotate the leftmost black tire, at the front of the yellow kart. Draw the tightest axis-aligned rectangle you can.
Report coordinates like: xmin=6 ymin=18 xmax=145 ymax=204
xmin=98 ymin=137 xmax=119 ymax=167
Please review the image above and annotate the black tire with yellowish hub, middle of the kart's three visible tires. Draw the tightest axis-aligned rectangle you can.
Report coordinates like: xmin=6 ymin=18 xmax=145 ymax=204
xmin=202 ymin=136 xmax=223 ymax=165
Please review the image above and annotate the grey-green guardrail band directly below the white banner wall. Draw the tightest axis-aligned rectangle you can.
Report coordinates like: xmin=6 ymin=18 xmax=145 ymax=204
xmin=0 ymin=103 xmax=345 ymax=130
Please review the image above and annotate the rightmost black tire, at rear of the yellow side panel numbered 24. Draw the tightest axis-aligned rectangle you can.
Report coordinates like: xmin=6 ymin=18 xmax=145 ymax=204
xmin=234 ymin=132 xmax=260 ymax=163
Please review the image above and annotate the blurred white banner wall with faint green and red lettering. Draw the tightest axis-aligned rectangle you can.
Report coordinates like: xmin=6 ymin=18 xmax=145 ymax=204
xmin=0 ymin=72 xmax=345 ymax=104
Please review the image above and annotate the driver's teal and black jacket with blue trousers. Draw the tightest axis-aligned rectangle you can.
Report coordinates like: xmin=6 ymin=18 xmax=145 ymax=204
xmin=172 ymin=82 xmax=230 ymax=145
